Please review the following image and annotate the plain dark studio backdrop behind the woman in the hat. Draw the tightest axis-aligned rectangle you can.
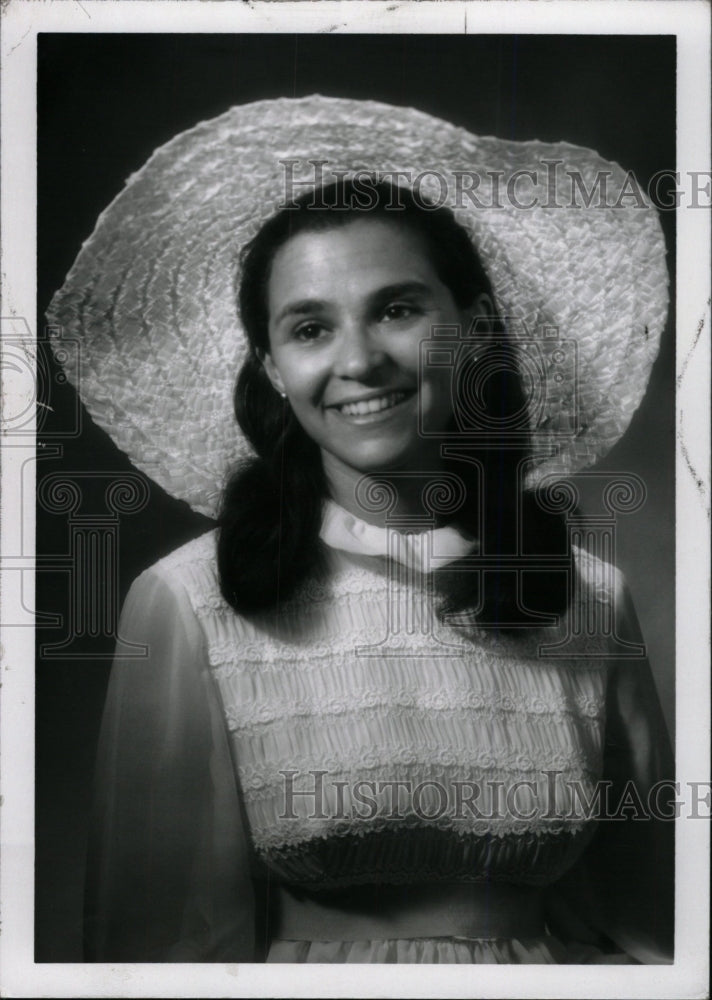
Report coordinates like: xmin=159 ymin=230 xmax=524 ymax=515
xmin=36 ymin=34 xmax=675 ymax=962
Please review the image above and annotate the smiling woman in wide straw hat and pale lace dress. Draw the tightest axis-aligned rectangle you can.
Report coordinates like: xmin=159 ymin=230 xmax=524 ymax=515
xmin=48 ymin=98 xmax=670 ymax=962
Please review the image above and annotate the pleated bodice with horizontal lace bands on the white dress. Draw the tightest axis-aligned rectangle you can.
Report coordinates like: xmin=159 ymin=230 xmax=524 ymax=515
xmin=152 ymin=534 xmax=614 ymax=887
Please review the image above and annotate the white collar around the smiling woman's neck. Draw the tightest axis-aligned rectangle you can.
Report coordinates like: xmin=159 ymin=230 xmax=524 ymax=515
xmin=319 ymin=500 xmax=477 ymax=573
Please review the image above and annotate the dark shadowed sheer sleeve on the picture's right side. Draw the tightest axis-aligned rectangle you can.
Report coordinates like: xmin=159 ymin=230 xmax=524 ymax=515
xmin=553 ymin=577 xmax=675 ymax=964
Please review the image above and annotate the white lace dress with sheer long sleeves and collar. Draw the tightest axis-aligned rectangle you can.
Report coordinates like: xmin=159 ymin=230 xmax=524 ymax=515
xmin=86 ymin=504 xmax=672 ymax=963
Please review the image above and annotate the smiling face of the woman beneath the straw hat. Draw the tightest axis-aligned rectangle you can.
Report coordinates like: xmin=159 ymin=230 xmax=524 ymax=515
xmin=265 ymin=219 xmax=467 ymax=484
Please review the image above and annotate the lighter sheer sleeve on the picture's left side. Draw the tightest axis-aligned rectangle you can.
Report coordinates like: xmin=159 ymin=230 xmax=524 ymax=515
xmin=85 ymin=568 xmax=254 ymax=962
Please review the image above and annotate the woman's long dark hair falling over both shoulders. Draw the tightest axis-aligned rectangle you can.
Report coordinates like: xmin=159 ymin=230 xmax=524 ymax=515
xmin=218 ymin=180 xmax=568 ymax=628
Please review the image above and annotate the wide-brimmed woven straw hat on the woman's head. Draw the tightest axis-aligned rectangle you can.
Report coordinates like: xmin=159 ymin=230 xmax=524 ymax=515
xmin=48 ymin=96 xmax=668 ymax=515
